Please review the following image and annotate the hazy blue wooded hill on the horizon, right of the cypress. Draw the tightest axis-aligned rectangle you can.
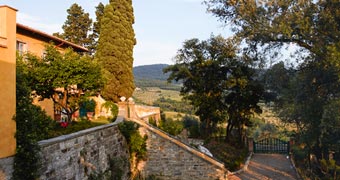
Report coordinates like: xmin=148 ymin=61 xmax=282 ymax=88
xmin=133 ymin=64 xmax=169 ymax=81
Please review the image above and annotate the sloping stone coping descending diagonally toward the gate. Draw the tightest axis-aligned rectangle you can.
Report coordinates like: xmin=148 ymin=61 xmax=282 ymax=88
xmin=129 ymin=118 xmax=230 ymax=174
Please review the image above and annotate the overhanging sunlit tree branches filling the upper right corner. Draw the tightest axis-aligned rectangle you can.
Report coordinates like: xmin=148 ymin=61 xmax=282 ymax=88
xmin=205 ymin=0 xmax=340 ymax=62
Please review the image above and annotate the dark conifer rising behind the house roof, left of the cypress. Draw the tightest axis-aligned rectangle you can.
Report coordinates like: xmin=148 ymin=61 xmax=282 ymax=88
xmin=54 ymin=3 xmax=92 ymax=47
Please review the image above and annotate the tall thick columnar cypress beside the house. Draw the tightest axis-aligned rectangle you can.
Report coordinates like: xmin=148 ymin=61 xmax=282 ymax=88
xmin=95 ymin=0 xmax=136 ymax=102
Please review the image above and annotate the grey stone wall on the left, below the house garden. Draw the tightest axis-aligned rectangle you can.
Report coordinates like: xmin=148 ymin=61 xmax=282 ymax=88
xmin=39 ymin=124 xmax=129 ymax=180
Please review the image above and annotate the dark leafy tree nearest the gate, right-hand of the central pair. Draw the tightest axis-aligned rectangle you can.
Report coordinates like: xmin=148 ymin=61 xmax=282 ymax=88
xmin=224 ymin=64 xmax=263 ymax=142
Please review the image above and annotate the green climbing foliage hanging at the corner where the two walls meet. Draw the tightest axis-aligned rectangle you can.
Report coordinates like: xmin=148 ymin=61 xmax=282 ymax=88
xmin=118 ymin=121 xmax=147 ymax=161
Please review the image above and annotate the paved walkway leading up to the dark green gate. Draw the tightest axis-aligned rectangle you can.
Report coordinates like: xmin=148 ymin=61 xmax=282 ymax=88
xmin=228 ymin=154 xmax=298 ymax=180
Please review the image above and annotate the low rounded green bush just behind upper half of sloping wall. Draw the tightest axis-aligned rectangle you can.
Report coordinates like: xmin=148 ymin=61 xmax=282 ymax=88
xmin=159 ymin=118 xmax=184 ymax=136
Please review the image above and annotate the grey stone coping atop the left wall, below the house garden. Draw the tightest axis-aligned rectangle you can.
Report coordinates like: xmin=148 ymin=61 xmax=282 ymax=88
xmin=38 ymin=117 xmax=124 ymax=147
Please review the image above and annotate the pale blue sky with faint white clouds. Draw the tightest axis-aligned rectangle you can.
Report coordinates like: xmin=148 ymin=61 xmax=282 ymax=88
xmin=0 ymin=0 xmax=231 ymax=66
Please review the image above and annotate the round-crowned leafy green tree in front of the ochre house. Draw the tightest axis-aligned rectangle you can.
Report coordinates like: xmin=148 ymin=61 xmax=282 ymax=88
xmin=25 ymin=46 xmax=103 ymax=120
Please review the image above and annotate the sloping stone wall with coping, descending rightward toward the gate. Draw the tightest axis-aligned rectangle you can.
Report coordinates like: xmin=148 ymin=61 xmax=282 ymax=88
xmin=131 ymin=119 xmax=229 ymax=180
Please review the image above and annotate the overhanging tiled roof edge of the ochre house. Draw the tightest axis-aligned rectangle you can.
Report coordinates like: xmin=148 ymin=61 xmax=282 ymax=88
xmin=17 ymin=23 xmax=89 ymax=52
